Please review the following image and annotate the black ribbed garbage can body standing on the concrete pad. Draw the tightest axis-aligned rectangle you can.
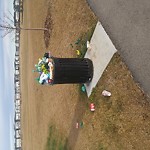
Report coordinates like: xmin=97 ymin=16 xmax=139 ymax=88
xmin=52 ymin=58 xmax=93 ymax=84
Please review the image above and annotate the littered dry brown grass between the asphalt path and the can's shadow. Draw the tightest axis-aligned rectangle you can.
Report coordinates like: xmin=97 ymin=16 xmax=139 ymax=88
xmin=76 ymin=54 xmax=150 ymax=150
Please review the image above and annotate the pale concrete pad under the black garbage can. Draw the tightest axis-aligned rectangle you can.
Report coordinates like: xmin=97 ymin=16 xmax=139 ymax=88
xmin=85 ymin=22 xmax=116 ymax=97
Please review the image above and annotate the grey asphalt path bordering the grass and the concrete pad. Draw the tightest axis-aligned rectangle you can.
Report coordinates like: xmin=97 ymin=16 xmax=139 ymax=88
xmin=87 ymin=0 xmax=150 ymax=96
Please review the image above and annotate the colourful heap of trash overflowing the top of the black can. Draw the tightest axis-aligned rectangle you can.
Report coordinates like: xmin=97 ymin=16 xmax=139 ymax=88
xmin=33 ymin=53 xmax=54 ymax=84
